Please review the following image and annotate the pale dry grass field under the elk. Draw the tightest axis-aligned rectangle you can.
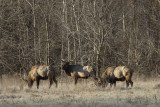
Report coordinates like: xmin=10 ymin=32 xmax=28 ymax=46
xmin=0 ymin=76 xmax=160 ymax=107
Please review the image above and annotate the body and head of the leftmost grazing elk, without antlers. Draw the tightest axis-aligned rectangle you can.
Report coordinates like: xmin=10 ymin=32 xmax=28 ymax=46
xmin=27 ymin=65 xmax=57 ymax=89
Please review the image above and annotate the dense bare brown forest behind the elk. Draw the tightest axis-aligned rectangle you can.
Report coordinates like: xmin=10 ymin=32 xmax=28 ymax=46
xmin=0 ymin=0 xmax=160 ymax=78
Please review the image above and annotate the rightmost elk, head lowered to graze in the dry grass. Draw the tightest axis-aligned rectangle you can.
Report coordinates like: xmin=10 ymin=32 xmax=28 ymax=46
xmin=98 ymin=66 xmax=134 ymax=87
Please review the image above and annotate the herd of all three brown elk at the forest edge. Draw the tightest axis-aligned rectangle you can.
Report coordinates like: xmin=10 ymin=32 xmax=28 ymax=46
xmin=20 ymin=60 xmax=134 ymax=89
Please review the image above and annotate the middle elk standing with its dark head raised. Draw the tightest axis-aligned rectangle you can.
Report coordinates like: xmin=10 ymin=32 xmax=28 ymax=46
xmin=62 ymin=60 xmax=97 ymax=85
